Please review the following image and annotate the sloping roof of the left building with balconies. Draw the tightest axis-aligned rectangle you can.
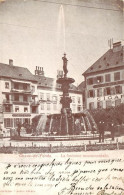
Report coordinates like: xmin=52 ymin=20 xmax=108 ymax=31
xmin=0 ymin=63 xmax=37 ymax=82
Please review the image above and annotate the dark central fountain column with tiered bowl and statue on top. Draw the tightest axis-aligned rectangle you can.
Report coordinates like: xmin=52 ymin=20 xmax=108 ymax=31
xmin=57 ymin=54 xmax=75 ymax=135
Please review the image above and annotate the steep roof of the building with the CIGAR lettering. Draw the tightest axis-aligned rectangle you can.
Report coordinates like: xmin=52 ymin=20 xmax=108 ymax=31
xmin=83 ymin=43 xmax=124 ymax=76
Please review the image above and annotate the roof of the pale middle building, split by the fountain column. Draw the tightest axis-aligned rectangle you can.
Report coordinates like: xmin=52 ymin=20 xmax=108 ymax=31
xmin=35 ymin=75 xmax=80 ymax=92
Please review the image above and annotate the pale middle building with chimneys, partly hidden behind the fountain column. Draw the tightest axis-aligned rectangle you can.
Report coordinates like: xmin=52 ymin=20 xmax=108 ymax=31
xmin=35 ymin=67 xmax=83 ymax=114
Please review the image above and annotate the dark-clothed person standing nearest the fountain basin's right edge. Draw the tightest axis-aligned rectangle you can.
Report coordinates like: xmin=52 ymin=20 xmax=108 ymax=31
xmin=98 ymin=120 xmax=105 ymax=143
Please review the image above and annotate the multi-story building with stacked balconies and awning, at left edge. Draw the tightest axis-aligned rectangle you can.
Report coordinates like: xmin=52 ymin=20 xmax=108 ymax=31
xmin=0 ymin=60 xmax=38 ymax=133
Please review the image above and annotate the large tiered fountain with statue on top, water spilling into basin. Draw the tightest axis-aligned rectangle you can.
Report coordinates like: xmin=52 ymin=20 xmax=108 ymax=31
xmin=10 ymin=54 xmax=97 ymax=141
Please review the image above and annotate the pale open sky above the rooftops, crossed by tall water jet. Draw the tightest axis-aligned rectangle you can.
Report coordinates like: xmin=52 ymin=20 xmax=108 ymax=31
xmin=0 ymin=0 xmax=123 ymax=85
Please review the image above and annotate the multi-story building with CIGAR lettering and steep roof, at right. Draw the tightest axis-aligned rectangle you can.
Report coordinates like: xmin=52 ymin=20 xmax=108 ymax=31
xmin=83 ymin=42 xmax=124 ymax=109
